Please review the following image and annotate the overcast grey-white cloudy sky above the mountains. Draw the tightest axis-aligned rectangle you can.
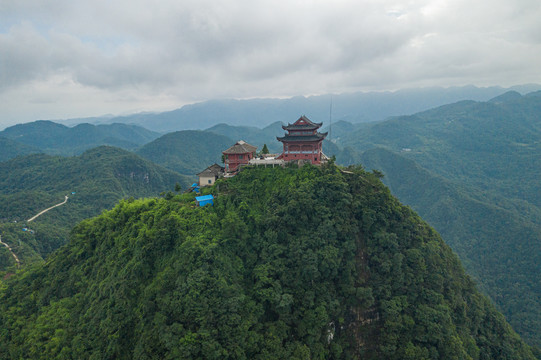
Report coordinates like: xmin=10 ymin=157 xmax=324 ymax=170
xmin=0 ymin=0 xmax=541 ymax=128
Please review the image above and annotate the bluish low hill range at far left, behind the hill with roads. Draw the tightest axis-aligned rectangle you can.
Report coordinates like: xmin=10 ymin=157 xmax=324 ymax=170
xmin=0 ymin=120 xmax=160 ymax=155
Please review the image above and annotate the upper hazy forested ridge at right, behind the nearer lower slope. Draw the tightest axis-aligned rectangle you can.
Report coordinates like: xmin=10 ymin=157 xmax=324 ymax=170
xmin=341 ymin=90 xmax=541 ymax=206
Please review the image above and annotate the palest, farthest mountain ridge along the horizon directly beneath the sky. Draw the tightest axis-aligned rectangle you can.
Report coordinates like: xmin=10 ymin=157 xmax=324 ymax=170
xmin=60 ymin=85 xmax=541 ymax=132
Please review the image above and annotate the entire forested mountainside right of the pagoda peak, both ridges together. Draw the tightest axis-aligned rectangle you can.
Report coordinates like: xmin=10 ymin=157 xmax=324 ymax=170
xmin=337 ymin=93 xmax=541 ymax=346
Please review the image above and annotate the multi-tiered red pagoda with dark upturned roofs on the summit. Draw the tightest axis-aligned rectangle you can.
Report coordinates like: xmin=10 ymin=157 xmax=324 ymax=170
xmin=276 ymin=115 xmax=327 ymax=164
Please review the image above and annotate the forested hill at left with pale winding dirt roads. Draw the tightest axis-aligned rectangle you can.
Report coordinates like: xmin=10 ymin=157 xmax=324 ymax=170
xmin=0 ymin=146 xmax=189 ymax=270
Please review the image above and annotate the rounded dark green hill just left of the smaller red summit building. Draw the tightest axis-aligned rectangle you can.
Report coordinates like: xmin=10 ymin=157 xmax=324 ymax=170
xmin=137 ymin=130 xmax=233 ymax=177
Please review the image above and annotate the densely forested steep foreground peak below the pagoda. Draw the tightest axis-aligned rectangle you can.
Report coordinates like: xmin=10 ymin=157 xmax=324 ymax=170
xmin=0 ymin=164 xmax=534 ymax=359
